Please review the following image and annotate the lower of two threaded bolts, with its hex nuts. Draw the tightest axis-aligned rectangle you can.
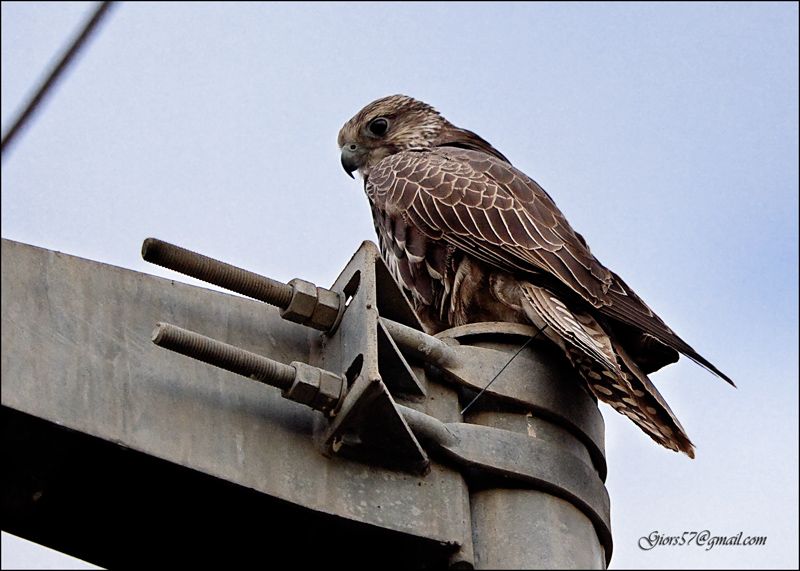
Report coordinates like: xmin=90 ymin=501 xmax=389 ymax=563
xmin=150 ymin=323 xmax=343 ymax=414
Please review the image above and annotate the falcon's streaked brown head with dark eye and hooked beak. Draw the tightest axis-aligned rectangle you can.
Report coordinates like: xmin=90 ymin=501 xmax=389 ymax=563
xmin=338 ymin=95 xmax=452 ymax=179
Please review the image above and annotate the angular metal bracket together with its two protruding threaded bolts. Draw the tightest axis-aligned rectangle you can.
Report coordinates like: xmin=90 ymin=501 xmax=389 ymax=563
xmin=142 ymin=238 xmax=430 ymax=473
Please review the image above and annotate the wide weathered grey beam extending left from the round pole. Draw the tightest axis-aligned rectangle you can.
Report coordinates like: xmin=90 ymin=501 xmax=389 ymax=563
xmin=2 ymin=240 xmax=469 ymax=565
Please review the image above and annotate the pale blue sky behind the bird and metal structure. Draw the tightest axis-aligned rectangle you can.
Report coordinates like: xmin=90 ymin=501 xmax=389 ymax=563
xmin=1 ymin=2 xmax=799 ymax=569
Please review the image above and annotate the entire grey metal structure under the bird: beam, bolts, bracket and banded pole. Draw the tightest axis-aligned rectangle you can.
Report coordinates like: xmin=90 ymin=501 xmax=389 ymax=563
xmin=2 ymin=239 xmax=612 ymax=569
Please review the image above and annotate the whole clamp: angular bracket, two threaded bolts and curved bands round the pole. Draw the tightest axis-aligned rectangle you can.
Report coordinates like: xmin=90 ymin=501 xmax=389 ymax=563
xmin=143 ymin=239 xmax=611 ymax=558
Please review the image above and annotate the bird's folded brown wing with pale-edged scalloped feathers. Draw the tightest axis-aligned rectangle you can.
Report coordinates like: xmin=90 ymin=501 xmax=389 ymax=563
xmin=365 ymin=147 xmax=733 ymax=384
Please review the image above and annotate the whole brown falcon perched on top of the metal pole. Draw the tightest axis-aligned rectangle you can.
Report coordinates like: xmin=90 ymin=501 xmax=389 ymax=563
xmin=338 ymin=95 xmax=735 ymax=458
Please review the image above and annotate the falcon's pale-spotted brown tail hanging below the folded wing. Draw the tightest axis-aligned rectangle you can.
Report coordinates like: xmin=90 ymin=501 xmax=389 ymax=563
xmin=519 ymin=281 xmax=694 ymax=458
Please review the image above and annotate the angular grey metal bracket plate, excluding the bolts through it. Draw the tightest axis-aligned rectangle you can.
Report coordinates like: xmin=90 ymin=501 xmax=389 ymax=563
xmin=312 ymin=242 xmax=429 ymax=473
